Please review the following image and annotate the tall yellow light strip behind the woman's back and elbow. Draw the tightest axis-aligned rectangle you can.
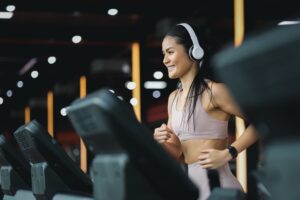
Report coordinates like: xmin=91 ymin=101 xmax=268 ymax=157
xmin=234 ymin=0 xmax=247 ymax=192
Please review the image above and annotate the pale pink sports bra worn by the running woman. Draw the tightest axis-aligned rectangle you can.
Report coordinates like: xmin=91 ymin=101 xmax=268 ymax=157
xmin=171 ymin=95 xmax=228 ymax=141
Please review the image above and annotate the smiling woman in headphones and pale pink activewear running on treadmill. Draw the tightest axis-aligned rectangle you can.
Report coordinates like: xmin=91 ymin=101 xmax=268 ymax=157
xmin=154 ymin=23 xmax=258 ymax=200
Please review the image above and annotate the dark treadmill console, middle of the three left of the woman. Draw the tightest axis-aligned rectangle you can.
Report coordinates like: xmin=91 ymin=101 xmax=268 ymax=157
xmin=14 ymin=120 xmax=92 ymax=200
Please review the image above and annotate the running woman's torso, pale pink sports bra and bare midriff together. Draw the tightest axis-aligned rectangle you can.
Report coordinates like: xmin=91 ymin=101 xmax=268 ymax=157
xmin=171 ymin=87 xmax=229 ymax=164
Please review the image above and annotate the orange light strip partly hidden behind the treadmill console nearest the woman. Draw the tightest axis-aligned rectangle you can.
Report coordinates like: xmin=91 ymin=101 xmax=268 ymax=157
xmin=79 ymin=76 xmax=87 ymax=173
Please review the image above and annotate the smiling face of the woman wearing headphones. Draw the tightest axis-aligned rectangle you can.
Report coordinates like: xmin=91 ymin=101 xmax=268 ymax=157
xmin=162 ymin=36 xmax=194 ymax=79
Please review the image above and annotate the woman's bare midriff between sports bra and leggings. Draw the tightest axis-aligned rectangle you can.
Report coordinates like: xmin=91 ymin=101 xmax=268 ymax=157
xmin=181 ymin=139 xmax=227 ymax=164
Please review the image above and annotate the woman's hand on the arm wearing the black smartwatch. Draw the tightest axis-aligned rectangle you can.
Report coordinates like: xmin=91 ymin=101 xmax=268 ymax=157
xmin=198 ymin=149 xmax=231 ymax=169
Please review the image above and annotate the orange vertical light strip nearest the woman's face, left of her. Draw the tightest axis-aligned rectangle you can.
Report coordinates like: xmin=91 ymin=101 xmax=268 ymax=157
xmin=131 ymin=42 xmax=141 ymax=121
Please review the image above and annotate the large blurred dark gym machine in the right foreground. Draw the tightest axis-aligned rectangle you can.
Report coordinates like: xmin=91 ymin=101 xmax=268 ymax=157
xmin=212 ymin=25 xmax=300 ymax=200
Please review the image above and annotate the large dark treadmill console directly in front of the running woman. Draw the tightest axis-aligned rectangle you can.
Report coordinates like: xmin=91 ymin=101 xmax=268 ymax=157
xmin=67 ymin=89 xmax=199 ymax=200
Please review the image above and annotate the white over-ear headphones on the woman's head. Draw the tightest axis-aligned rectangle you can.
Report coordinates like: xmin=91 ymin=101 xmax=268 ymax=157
xmin=177 ymin=23 xmax=204 ymax=61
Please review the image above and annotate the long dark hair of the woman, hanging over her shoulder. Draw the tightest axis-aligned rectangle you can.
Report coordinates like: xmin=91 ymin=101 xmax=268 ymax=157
xmin=166 ymin=22 xmax=212 ymax=128
